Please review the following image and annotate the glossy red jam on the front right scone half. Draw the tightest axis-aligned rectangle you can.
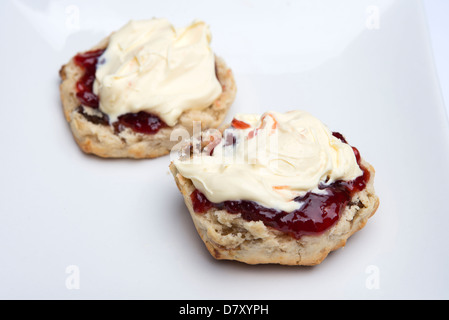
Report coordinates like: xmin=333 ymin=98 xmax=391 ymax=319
xmin=190 ymin=133 xmax=370 ymax=239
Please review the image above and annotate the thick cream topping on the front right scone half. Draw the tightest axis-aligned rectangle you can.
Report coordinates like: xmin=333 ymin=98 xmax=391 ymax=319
xmin=174 ymin=111 xmax=362 ymax=212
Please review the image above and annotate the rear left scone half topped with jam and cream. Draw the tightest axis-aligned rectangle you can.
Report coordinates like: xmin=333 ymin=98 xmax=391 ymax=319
xmin=60 ymin=18 xmax=236 ymax=158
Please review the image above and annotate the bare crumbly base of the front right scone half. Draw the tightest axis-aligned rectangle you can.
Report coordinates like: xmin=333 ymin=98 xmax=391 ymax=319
xmin=170 ymin=159 xmax=379 ymax=266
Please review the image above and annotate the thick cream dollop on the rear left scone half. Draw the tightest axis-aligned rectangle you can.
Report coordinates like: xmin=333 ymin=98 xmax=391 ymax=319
xmin=94 ymin=19 xmax=222 ymax=126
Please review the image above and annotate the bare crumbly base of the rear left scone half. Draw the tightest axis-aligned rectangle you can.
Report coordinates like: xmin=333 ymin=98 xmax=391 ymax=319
xmin=59 ymin=38 xmax=237 ymax=159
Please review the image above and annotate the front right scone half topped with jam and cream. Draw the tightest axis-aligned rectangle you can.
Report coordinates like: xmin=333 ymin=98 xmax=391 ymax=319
xmin=170 ymin=111 xmax=379 ymax=265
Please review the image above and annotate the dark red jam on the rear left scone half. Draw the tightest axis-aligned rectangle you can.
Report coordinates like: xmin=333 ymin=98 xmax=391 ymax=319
xmin=74 ymin=49 xmax=167 ymax=134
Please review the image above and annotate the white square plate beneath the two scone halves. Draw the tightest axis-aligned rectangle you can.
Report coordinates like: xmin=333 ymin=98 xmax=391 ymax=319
xmin=0 ymin=0 xmax=449 ymax=299
